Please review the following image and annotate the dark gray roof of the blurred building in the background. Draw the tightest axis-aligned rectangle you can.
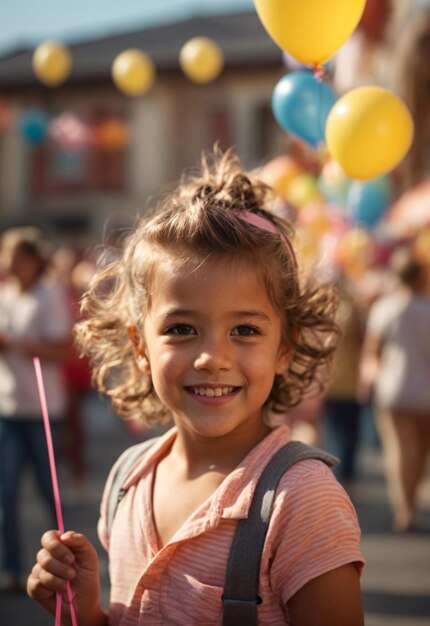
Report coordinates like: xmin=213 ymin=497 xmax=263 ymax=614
xmin=0 ymin=11 xmax=281 ymax=89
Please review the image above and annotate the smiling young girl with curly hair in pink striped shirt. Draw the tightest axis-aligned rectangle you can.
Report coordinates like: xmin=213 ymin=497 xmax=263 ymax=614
xmin=28 ymin=151 xmax=363 ymax=626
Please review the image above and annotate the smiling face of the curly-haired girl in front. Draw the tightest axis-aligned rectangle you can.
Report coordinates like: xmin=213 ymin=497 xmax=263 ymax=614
xmin=134 ymin=252 xmax=289 ymax=437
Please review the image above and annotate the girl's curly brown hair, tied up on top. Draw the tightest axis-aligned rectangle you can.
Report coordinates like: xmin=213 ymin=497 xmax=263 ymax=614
xmin=75 ymin=149 xmax=338 ymax=424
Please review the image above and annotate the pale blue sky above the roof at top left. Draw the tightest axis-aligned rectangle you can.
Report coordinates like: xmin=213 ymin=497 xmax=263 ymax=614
xmin=0 ymin=0 xmax=253 ymax=54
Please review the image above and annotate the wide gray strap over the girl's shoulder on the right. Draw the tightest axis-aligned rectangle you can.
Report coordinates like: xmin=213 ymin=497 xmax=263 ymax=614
xmin=223 ymin=441 xmax=338 ymax=626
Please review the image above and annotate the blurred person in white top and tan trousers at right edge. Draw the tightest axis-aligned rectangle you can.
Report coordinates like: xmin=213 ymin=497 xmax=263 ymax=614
xmin=360 ymin=247 xmax=430 ymax=532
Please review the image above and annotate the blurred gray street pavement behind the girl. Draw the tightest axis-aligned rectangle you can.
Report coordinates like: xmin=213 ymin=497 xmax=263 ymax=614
xmin=0 ymin=399 xmax=430 ymax=626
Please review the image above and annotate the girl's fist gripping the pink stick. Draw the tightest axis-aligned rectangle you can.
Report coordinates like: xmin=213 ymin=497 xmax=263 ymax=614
xmin=27 ymin=530 xmax=107 ymax=626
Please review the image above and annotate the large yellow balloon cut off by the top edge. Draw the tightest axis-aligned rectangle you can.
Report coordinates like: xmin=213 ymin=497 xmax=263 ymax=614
xmin=254 ymin=0 xmax=366 ymax=64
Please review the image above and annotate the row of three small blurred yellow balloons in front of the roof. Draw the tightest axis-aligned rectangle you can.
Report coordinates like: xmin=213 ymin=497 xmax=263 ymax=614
xmin=32 ymin=37 xmax=224 ymax=96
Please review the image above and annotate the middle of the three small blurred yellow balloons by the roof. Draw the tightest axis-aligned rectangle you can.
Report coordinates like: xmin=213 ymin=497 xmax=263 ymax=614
xmin=112 ymin=48 xmax=155 ymax=96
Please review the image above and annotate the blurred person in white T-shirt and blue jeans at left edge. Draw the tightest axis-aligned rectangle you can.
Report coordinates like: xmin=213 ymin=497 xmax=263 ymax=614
xmin=0 ymin=227 xmax=71 ymax=592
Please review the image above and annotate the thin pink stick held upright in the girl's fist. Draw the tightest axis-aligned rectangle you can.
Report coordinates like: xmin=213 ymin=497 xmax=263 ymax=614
xmin=33 ymin=357 xmax=78 ymax=626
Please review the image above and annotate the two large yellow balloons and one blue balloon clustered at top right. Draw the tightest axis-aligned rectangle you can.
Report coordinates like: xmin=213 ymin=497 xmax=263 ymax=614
xmin=254 ymin=0 xmax=413 ymax=181
